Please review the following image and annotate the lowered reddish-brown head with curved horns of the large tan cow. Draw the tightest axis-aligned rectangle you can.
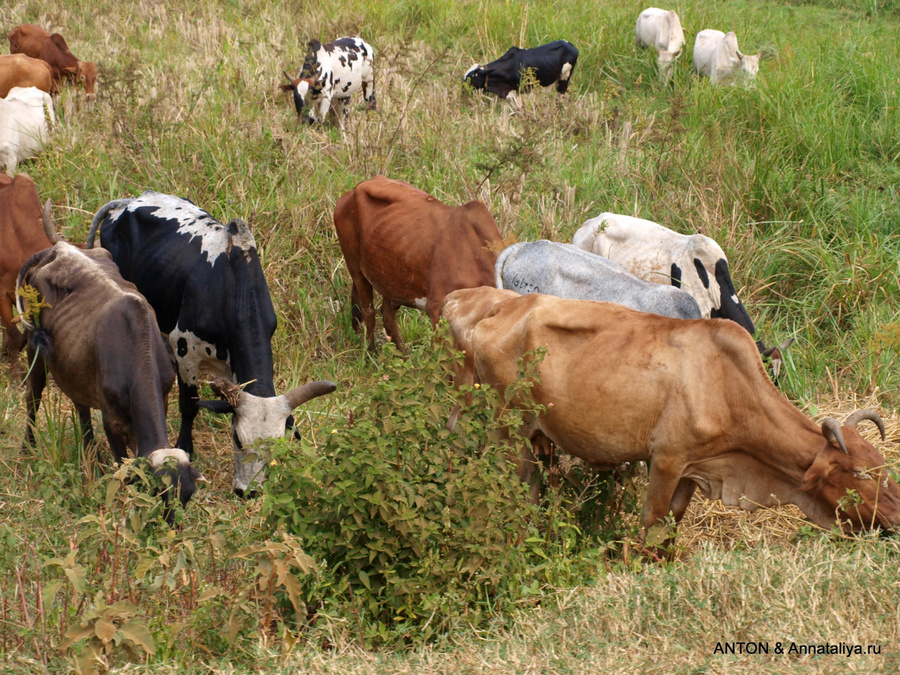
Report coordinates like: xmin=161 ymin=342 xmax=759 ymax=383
xmin=800 ymin=410 xmax=900 ymax=531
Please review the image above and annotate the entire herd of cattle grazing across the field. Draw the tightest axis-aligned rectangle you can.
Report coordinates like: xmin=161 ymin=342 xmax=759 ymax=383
xmin=0 ymin=8 xmax=900 ymax=540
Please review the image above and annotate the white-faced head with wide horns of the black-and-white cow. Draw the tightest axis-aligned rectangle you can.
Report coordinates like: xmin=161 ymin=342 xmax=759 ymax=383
xmin=200 ymin=377 xmax=337 ymax=497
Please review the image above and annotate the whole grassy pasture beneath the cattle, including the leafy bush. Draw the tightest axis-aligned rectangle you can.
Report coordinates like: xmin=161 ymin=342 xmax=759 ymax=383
xmin=0 ymin=0 xmax=900 ymax=673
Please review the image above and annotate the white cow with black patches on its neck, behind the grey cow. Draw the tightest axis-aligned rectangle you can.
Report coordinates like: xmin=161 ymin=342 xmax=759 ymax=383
xmin=572 ymin=213 xmax=792 ymax=376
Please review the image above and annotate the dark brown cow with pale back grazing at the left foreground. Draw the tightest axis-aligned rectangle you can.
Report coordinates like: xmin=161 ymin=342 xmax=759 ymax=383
xmin=16 ymin=242 xmax=205 ymax=521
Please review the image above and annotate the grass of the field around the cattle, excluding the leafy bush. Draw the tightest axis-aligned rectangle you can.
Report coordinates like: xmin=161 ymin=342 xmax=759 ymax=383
xmin=0 ymin=0 xmax=900 ymax=673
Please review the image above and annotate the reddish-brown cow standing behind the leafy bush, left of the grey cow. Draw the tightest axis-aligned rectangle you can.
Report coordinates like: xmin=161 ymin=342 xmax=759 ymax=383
xmin=334 ymin=176 xmax=501 ymax=351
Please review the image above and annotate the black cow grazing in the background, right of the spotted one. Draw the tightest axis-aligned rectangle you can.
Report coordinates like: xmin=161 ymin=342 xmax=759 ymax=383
xmin=463 ymin=40 xmax=578 ymax=103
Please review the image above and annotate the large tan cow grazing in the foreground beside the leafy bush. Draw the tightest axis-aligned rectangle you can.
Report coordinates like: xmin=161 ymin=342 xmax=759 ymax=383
xmin=454 ymin=289 xmax=900 ymax=536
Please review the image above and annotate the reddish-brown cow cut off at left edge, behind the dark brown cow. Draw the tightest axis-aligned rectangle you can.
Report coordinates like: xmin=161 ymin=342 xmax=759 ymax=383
xmin=0 ymin=173 xmax=50 ymax=381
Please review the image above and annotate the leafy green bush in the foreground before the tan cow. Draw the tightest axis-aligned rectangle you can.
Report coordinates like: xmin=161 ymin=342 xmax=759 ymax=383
xmin=263 ymin=341 xmax=608 ymax=644
